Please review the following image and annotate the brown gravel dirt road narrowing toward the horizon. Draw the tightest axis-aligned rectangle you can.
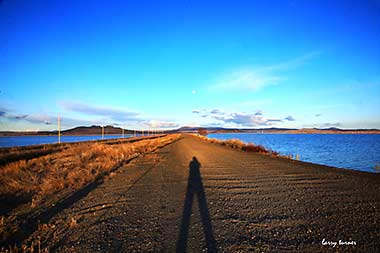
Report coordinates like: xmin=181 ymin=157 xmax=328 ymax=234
xmin=29 ymin=135 xmax=380 ymax=252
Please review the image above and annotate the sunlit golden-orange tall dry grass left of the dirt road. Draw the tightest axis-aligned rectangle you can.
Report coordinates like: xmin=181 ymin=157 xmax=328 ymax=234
xmin=0 ymin=135 xmax=178 ymax=211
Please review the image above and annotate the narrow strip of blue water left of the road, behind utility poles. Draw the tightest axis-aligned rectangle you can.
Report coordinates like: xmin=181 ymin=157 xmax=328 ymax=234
xmin=0 ymin=134 xmax=132 ymax=147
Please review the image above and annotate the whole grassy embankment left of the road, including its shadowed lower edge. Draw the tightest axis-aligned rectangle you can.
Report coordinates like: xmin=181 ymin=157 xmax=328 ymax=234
xmin=0 ymin=134 xmax=179 ymax=251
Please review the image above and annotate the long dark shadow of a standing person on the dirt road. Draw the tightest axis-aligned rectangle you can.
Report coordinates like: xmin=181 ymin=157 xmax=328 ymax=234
xmin=176 ymin=157 xmax=217 ymax=252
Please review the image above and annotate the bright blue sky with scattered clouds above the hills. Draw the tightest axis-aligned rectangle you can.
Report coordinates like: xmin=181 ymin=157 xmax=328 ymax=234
xmin=0 ymin=0 xmax=380 ymax=130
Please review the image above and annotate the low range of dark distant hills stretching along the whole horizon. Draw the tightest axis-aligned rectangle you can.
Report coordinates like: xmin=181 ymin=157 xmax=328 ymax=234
xmin=0 ymin=126 xmax=380 ymax=136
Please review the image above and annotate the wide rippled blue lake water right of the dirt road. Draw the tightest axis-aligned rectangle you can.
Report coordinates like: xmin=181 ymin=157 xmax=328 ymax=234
xmin=208 ymin=133 xmax=380 ymax=172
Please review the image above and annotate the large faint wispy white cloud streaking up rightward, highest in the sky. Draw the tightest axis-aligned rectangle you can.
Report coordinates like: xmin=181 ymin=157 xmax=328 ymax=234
xmin=211 ymin=52 xmax=320 ymax=91
